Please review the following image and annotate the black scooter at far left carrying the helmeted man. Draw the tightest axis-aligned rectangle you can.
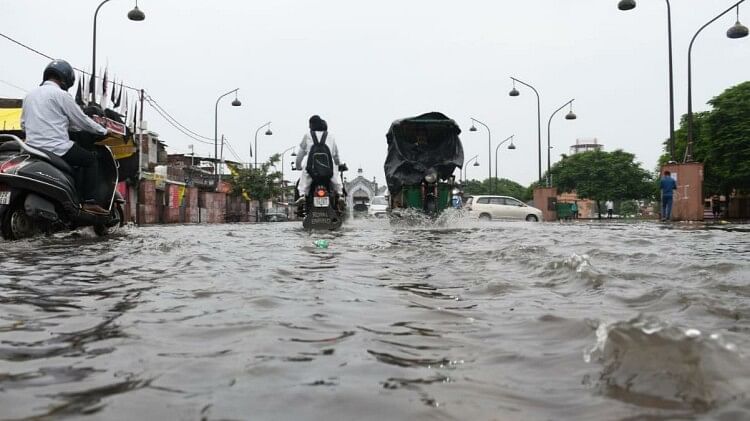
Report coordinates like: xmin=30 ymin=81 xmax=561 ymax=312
xmin=0 ymin=134 xmax=125 ymax=240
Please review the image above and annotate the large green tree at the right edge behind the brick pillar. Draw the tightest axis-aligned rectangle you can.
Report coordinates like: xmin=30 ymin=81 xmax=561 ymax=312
xmin=659 ymin=81 xmax=750 ymax=197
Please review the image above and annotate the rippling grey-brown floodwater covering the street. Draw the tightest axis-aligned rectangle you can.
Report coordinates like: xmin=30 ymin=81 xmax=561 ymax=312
xmin=0 ymin=220 xmax=750 ymax=420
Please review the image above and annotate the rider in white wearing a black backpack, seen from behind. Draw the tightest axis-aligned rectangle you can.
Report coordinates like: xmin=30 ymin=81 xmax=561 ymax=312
xmin=296 ymin=115 xmax=344 ymax=204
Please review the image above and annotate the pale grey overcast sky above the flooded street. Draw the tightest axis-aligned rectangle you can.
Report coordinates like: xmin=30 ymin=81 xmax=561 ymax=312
xmin=0 ymin=0 xmax=750 ymax=185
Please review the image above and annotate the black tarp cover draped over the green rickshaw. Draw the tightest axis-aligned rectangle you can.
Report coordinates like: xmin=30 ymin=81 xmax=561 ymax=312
xmin=384 ymin=112 xmax=464 ymax=194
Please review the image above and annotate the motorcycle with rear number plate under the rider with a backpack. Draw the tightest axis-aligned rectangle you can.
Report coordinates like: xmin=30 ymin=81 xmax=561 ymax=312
xmin=294 ymin=164 xmax=349 ymax=230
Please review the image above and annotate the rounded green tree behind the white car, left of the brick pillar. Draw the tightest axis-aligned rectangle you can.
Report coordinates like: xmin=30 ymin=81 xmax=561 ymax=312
xmin=550 ymin=149 xmax=654 ymax=213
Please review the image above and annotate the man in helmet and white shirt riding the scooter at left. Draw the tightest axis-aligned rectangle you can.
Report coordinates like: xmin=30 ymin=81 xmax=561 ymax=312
xmin=21 ymin=60 xmax=109 ymax=215
